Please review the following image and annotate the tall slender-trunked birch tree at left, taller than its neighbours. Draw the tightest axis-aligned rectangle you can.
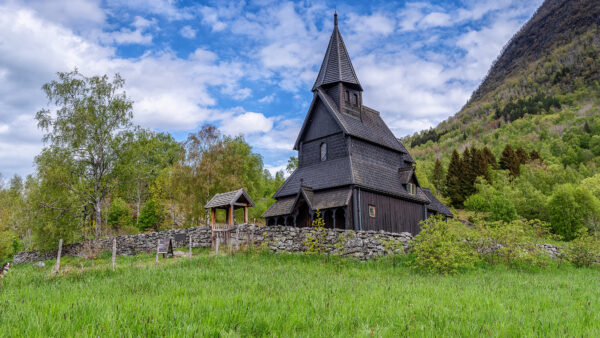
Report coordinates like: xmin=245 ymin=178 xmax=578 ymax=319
xmin=36 ymin=69 xmax=133 ymax=238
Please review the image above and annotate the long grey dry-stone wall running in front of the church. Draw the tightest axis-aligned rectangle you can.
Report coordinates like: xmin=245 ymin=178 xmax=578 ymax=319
xmin=13 ymin=225 xmax=412 ymax=264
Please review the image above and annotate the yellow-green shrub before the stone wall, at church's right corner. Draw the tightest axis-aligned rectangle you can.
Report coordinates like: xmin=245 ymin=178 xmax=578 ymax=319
xmin=411 ymin=217 xmax=479 ymax=274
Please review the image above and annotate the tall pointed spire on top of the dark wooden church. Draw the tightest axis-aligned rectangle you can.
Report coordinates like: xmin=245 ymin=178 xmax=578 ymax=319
xmin=312 ymin=12 xmax=362 ymax=91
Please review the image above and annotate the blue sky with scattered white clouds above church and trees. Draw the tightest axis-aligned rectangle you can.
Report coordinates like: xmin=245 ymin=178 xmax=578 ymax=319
xmin=0 ymin=0 xmax=542 ymax=177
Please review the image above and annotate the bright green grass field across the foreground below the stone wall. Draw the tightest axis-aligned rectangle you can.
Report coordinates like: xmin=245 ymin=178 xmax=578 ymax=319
xmin=0 ymin=251 xmax=600 ymax=337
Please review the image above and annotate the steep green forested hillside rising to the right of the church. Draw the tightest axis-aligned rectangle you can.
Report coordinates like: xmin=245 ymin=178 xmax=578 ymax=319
xmin=404 ymin=0 xmax=600 ymax=239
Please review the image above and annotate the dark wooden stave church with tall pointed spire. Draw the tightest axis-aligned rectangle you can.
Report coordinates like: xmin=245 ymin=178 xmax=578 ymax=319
xmin=263 ymin=14 xmax=452 ymax=234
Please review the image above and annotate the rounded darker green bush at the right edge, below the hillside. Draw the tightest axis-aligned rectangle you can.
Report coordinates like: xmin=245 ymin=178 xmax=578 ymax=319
xmin=547 ymin=184 xmax=600 ymax=240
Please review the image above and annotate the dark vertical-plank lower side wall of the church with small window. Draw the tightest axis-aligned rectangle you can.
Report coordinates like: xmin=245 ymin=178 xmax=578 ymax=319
xmin=360 ymin=190 xmax=424 ymax=235
